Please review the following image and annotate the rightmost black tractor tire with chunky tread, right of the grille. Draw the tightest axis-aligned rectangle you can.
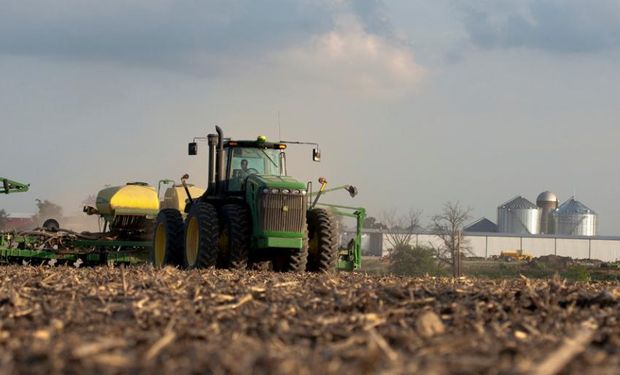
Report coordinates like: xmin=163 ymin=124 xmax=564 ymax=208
xmin=307 ymin=208 xmax=339 ymax=273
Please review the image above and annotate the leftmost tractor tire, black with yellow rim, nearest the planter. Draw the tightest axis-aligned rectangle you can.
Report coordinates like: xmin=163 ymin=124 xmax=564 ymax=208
xmin=150 ymin=208 xmax=183 ymax=268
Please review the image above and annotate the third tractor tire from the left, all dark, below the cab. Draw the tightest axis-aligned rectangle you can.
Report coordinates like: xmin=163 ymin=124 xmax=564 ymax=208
xmin=220 ymin=204 xmax=252 ymax=270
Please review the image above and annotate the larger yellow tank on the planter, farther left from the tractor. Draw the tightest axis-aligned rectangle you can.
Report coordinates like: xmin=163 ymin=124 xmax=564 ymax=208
xmin=97 ymin=182 xmax=159 ymax=218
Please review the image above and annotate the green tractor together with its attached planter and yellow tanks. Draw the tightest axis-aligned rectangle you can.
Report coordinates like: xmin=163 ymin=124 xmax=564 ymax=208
xmin=0 ymin=137 xmax=366 ymax=272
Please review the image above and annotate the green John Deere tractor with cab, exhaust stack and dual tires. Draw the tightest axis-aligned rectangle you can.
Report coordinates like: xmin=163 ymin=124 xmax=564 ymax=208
xmin=151 ymin=127 xmax=339 ymax=272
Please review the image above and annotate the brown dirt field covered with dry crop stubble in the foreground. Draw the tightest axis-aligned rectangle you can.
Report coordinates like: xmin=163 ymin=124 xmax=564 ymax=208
xmin=0 ymin=266 xmax=620 ymax=374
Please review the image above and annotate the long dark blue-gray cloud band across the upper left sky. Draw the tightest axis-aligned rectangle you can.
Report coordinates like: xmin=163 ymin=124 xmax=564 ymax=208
xmin=0 ymin=0 xmax=398 ymax=70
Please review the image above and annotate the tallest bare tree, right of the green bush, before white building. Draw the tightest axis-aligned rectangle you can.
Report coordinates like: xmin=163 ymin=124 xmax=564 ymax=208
xmin=431 ymin=202 xmax=471 ymax=277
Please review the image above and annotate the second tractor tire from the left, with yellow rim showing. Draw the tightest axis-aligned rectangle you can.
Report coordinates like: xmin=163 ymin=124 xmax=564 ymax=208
xmin=182 ymin=202 xmax=219 ymax=268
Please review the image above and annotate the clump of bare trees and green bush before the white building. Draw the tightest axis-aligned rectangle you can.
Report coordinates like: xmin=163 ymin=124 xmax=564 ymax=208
xmin=366 ymin=202 xmax=471 ymax=277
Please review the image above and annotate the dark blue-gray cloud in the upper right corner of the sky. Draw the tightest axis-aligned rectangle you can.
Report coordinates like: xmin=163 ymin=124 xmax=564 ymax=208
xmin=456 ymin=0 xmax=620 ymax=53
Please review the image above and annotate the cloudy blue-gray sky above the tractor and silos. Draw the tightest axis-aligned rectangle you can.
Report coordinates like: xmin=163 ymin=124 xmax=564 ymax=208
xmin=0 ymin=0 xmax=620 ymax=235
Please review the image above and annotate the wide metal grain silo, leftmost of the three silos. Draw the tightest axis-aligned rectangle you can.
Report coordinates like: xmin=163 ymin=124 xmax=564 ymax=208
xmin=497 ymin=196 xmax=541 ymax=234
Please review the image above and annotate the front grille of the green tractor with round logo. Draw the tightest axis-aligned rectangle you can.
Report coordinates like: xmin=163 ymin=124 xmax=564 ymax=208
xmin=258 ymin=194 xmax=306 ymax=232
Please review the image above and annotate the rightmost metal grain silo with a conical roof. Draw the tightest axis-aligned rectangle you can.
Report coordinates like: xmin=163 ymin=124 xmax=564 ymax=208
xmin=553 ymin=197 xmax=598 ymax=236
